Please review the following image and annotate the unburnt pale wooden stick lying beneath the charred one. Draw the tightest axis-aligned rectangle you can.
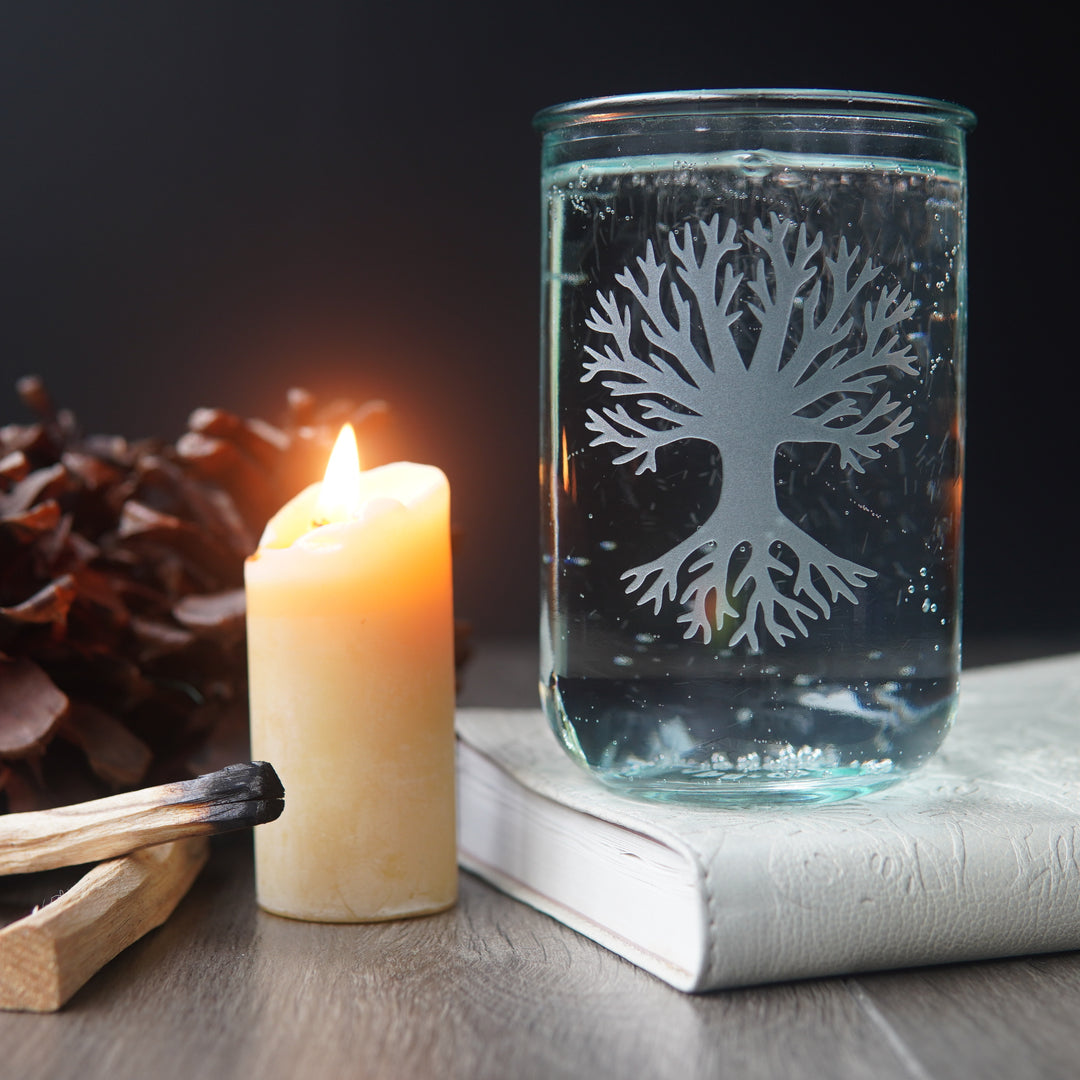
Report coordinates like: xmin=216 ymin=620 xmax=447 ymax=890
xmin=0 ymin=837 xmax=208 ymax=1012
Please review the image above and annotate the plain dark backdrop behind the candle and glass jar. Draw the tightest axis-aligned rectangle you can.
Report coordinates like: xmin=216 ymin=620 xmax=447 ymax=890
xmin=0 ymin=0 xmax=1080 ymax=645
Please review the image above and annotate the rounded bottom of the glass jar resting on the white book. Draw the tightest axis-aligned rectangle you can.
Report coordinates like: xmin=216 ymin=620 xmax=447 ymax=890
xmin=542 ymin=676 xmax=957 ymax=806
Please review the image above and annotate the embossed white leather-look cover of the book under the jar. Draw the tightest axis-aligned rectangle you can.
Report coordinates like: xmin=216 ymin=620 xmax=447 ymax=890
xmin=458 ymin=656 xmax=1080 ymax=990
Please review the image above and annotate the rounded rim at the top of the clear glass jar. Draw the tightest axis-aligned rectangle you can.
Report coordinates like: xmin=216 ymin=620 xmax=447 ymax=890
xmin=532 ymin=87 xmax=975 ymax=135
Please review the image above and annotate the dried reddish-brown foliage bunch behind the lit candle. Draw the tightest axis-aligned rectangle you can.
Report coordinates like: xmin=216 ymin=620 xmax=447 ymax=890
xmin=0 ymin=377 xmax=468 ymax=811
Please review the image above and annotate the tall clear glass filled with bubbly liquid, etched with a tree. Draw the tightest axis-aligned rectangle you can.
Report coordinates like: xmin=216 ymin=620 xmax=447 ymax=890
xmin=536 ymin=90 xmax=974 ymax=801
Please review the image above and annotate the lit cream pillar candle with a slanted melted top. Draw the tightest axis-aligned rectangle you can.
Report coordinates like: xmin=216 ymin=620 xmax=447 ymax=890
xmin=244 ymin=426 xmax=457 ymax=922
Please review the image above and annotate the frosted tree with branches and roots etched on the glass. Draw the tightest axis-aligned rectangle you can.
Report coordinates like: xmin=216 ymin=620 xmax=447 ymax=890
xmin=581 ymin=214 xmax=917 ymax=652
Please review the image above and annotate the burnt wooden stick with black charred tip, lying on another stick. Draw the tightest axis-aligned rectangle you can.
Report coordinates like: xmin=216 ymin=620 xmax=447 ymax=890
xmin=0 ymin=761 xmax=285 ymax=874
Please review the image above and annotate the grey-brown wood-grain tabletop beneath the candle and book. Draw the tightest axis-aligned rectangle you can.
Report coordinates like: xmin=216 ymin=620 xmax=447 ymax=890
xmin=0 ymin=648 xmax=1080 ymax=1080
